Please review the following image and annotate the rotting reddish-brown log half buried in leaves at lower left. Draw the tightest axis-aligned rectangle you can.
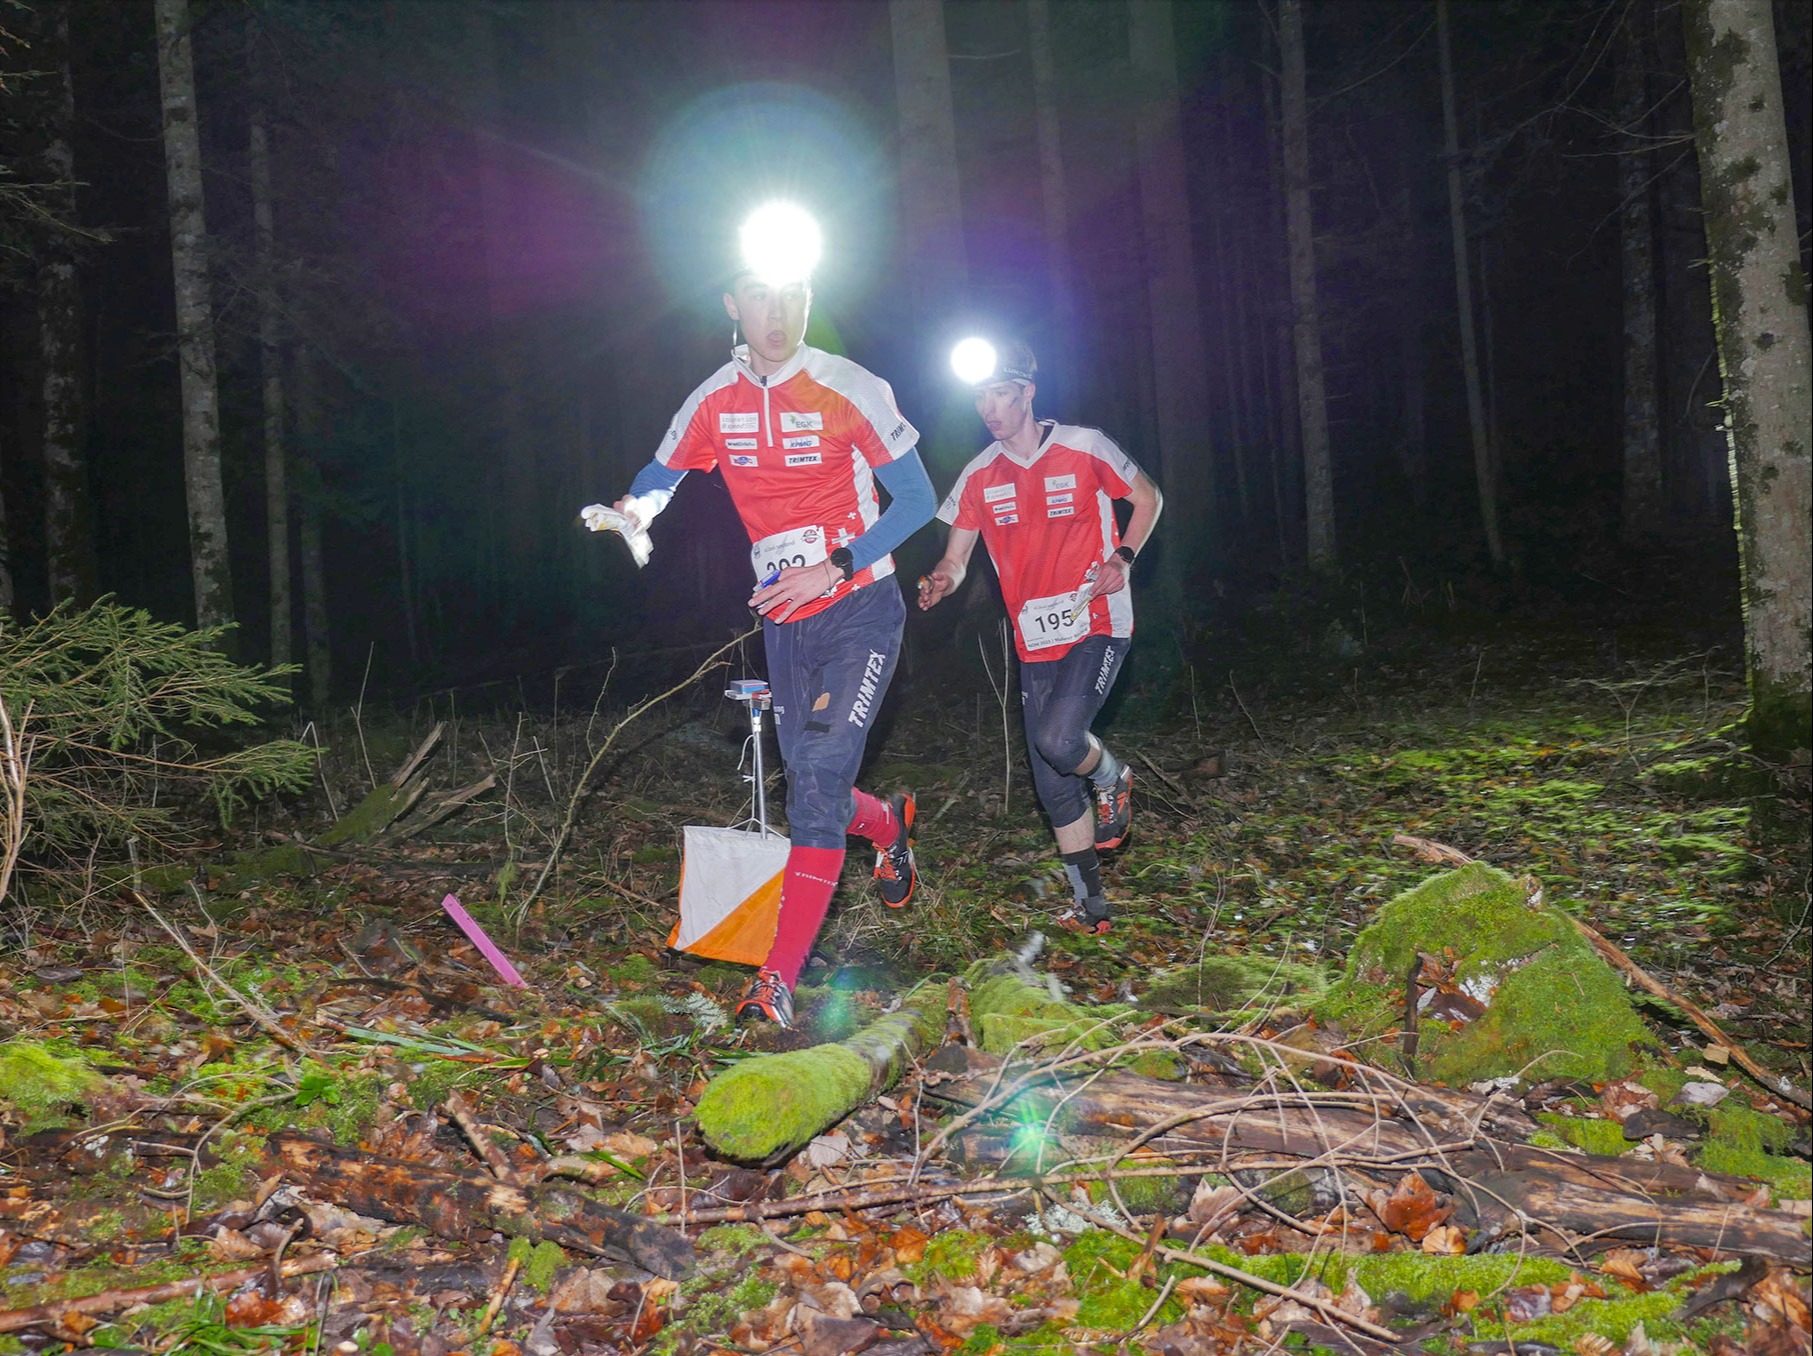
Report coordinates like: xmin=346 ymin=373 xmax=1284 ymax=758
xmin=267 ymin=1133 xmax=693 ymax=1278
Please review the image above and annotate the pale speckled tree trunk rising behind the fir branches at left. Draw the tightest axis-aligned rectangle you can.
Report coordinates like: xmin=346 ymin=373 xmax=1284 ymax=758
xmin=156 ymin=0 xmax=234 ymax=645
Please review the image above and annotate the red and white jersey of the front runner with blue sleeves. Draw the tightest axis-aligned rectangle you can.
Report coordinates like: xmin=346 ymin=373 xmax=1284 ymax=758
xmin=654 ymin=344 xmax=919 ymax=622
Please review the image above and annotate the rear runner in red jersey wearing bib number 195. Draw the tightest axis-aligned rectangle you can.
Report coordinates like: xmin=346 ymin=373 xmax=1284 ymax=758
xmin=919 ymin=344 xmax=1164 ymax=934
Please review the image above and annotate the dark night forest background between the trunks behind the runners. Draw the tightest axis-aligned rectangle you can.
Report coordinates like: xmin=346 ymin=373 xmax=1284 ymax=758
xmin=0 ymin=0 xmax=1813 ymax=696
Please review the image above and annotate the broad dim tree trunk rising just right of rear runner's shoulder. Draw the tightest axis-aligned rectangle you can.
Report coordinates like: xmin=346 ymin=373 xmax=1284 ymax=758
xmin=1128 ymin=0 xmax=1215 ymax=561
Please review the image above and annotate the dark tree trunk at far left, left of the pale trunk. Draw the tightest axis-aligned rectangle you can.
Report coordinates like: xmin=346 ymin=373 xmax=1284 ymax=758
xmin=38 ymin=4 xmax=94 ymax=604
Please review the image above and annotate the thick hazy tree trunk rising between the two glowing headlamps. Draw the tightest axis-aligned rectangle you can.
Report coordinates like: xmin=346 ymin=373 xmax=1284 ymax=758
xmin=888 ymin=0 xmax=971 ymax=319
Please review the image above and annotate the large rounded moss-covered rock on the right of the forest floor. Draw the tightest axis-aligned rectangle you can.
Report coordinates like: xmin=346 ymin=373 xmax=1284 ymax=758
xmin=1320 ymin=861 xmax=1655 ymax=1084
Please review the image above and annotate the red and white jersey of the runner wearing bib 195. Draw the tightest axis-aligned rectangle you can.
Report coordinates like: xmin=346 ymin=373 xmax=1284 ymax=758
xmin=937 ymin=424 xmax=1139 ymax=663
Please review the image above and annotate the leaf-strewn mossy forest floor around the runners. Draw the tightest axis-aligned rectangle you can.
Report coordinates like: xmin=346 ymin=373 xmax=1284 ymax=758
xmin=0 ymin=565 xmax=1813 ymax=1356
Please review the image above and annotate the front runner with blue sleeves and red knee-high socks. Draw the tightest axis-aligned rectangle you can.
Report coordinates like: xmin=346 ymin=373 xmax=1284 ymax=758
xmin=591 ymin=251 xmax=936 ymax=1026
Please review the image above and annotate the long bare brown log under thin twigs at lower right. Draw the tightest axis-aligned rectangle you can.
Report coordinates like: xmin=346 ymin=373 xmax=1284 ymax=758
xmin=926 ymin=1051 xmax=1806 ymax=1265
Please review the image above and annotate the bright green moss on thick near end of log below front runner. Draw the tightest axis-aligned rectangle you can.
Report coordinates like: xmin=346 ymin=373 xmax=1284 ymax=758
xmin=694 ymin=1044 xmax=870 ymax=1162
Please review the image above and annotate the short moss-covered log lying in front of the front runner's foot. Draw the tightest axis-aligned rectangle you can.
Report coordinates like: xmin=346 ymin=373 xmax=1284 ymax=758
xmin=694 ymin=981 xmax=946 ymax=1162
